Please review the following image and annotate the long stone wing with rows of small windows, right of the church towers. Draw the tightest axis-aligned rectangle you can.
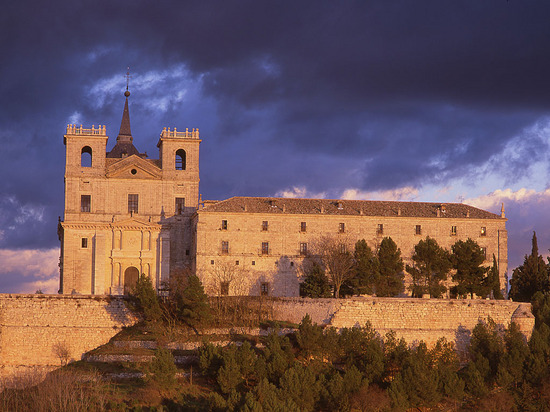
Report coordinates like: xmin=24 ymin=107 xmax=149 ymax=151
xmin=193 ymin=197 xmax=508 ymax=297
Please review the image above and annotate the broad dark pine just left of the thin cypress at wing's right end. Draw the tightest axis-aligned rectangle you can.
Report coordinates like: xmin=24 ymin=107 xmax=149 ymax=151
xmin=451 ymin=238 xmax=489 ymax=296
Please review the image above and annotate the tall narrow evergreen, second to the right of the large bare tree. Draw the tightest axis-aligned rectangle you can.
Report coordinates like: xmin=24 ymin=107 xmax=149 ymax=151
xmin=374 ymin=237 xmax=405 ymax=296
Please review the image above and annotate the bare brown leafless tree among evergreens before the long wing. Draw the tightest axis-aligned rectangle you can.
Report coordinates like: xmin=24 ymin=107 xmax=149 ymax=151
xmin=304 ymin=235 xmax=354 ymax=298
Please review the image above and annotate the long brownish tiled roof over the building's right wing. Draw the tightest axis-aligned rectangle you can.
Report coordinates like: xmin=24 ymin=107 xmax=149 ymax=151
xmin=199 ymin=197 xmax=501 ymax=219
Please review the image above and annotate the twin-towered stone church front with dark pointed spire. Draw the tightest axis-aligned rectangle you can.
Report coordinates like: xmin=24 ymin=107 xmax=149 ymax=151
xmin=58 ymin=93 xmax=201 ymax=295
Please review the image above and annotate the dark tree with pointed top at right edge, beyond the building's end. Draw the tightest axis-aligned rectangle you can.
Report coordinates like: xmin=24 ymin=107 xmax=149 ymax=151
xmin=510 ymin=232 xmax=550 ymax=302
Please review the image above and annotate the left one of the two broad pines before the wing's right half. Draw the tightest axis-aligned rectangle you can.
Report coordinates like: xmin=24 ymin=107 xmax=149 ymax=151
xmin=407 ymin=236 xmax=451 ymax=298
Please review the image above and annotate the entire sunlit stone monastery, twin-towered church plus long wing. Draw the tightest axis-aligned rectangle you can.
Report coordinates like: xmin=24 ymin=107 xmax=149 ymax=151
xmin=58 ymin=91 xmax=508 ymax=296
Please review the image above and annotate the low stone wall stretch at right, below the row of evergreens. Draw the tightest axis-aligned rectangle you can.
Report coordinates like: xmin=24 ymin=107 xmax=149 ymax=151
xmin=273 ymin=297 xmax=535 ymax=351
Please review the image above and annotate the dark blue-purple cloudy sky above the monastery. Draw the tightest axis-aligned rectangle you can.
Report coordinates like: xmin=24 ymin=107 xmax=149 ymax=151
xmin=0 ymin=0 xmax=550 ymax=292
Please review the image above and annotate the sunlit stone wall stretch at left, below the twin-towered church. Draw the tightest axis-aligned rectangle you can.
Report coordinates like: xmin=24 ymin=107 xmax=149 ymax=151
xmin=0 ymin=294 xmax=137 ymax=374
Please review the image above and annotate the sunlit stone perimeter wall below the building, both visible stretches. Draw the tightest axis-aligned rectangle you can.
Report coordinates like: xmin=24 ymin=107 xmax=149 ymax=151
xmin=0 ymin=294 xmax=534 ymax=374
